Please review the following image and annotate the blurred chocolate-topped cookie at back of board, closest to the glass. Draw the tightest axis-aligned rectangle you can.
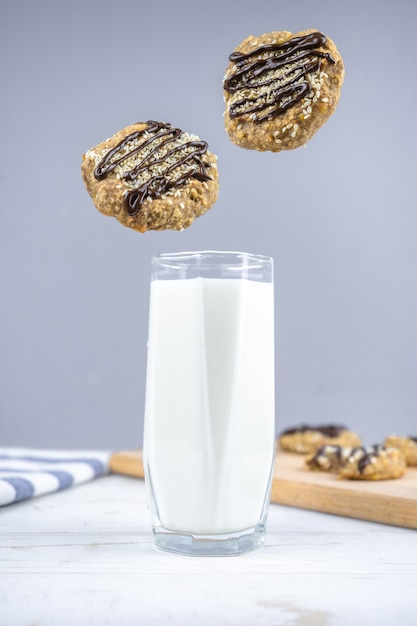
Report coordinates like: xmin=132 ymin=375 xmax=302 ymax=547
xmin=278 ymin=424 xmax=362 ymax=454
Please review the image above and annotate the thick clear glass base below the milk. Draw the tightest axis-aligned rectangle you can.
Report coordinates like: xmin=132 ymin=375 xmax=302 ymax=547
xmin=154 ymin=525 xmax=265 ymax=556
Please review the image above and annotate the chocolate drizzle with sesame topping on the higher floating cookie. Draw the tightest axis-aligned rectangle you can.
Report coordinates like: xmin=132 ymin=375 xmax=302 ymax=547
xmin=223 ymin=32 xmax=335 ymax=123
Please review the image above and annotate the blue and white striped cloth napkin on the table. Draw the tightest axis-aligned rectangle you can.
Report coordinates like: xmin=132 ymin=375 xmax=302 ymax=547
xmin=0 ymin=447 xmax=110 ymax=506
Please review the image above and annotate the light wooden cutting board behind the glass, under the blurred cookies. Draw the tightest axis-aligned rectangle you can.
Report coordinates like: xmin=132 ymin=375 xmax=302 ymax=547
xmin=110 ymin=450 xmax=417 ymax=529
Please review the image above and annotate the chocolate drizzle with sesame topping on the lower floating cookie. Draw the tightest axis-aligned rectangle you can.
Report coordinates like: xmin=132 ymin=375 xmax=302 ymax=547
xmin=94 ymin=121 xmax=211 ymax=216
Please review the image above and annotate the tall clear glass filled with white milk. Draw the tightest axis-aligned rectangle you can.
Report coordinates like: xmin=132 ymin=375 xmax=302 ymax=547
xmin=143 ymin=251 xmax=275 ymax=556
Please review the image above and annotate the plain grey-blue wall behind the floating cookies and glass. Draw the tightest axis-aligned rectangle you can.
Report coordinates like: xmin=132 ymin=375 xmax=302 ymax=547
xmin=0 ymin=0 xmax=417 ymax=449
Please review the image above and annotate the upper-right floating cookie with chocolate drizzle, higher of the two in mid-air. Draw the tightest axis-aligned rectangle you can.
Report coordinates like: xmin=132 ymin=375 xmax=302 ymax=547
xmin=223 ymin=30 xmax=344 ymax=152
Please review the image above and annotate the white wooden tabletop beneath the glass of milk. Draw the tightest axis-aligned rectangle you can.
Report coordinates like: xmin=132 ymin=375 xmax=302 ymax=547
xmin=0 ymin=475 xmax=417 ymax=626
